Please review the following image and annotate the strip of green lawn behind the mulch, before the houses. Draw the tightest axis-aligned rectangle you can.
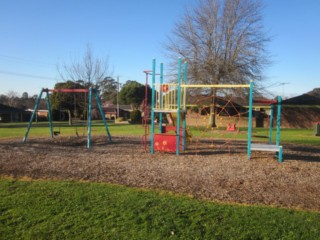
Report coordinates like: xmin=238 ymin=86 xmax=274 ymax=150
xmin=0 ymin=121 xmax=320 ymax=145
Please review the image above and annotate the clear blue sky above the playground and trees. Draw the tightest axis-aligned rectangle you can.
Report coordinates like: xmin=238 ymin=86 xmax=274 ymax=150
xmin=0 ymin=0 xmax=320 ymax=97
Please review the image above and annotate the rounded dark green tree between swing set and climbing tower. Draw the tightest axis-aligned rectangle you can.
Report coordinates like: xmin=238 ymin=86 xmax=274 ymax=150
xmin=119 ymin=80 xmax=151 ymax=109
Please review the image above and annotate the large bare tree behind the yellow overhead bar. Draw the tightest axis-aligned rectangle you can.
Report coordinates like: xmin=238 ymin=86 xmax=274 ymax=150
xmin=166 ymin=0 xmax=270 ymax=126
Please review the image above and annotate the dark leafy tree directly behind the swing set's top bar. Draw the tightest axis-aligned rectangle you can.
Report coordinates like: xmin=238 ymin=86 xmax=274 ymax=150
xmin=50 ymin=80 xmax=87 ymax=125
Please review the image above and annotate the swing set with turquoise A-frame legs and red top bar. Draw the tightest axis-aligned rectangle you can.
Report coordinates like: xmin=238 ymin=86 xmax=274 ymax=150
xmin=22 ymin=88 xmax=112 ymax=148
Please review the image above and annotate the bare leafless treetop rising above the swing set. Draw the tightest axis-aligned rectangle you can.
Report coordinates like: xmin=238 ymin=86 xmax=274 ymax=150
xmin=57 ymin=45 xmax=110 ymax=87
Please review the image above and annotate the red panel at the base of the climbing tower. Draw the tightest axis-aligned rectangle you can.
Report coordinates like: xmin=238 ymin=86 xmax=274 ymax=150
xmin=154 ymin=134 xmax=182 ymax=152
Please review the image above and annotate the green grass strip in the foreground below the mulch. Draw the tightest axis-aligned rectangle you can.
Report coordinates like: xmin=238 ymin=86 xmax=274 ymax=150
xmin=0 ymin=178 xmax=320 ymax=240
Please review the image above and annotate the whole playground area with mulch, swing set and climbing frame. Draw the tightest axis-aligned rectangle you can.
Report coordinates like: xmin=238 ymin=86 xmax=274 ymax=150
xmin=0 ymin=60 xmax=320 ymax=211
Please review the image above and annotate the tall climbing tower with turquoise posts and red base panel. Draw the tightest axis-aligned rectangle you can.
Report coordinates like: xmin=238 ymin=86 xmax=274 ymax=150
xmin=150 ymin=59 xmax=188 ymax=155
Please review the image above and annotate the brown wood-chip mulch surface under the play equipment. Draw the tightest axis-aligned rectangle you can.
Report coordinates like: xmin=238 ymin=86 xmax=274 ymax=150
xmin=0 ymin=137 xmax=320 ymax=211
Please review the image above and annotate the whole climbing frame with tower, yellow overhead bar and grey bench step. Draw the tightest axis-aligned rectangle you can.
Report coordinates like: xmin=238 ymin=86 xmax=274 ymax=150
xmin=147 ymin=59 xmax=282 ymax=162
